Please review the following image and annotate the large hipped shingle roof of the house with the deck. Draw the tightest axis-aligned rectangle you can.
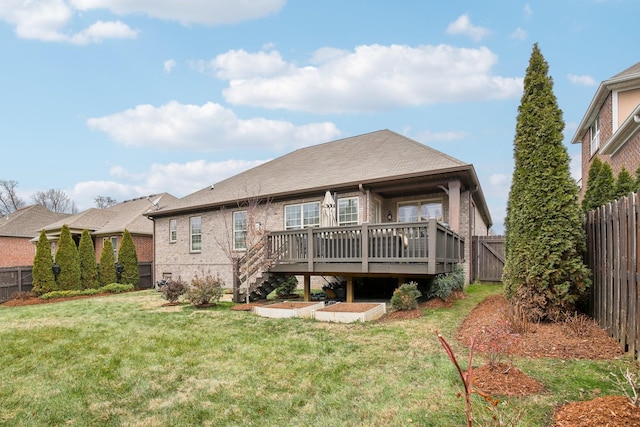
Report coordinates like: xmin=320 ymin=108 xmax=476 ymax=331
xmin=159 ymin=130 xmax=467 ymax=211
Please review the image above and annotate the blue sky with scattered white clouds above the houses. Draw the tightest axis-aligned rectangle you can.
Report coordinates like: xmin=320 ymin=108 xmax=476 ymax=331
xmin=0 ymin=0 xmax=640 ymax=233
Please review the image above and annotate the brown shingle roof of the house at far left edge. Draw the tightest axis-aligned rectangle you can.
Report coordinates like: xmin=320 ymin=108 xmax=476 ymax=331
xmin=0 ymin=205 xmax=71 ymax=238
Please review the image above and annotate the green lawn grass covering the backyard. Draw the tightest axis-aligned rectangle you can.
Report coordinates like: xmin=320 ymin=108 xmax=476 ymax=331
xmin=0 ymin=285 xmax=634 ymax=426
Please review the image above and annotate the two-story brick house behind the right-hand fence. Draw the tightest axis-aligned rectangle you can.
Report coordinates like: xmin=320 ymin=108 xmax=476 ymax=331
xmin=572 ymin=62 xmax=640 ymax=198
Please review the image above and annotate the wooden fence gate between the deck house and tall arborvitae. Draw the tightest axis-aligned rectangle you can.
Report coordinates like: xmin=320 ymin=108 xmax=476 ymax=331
xmin=470 ymin=236 xmax=504 ymax=282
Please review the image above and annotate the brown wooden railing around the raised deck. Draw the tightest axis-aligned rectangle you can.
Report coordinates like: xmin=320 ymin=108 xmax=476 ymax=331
xmin=267 ymin=219 xmax=464 ymax=274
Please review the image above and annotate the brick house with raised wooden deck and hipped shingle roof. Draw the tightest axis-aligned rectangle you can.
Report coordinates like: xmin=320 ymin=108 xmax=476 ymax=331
xmin=147 ymin=130 xmax=491 ymax=301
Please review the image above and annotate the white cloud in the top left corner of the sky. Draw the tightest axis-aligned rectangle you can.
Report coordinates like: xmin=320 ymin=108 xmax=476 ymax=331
xmin=0 ymin=0 xmax=286 ymax=45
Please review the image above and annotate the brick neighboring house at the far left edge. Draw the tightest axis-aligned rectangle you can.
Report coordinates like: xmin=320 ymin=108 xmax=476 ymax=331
xmin=0 ymin=205 xmax=70 ymax=267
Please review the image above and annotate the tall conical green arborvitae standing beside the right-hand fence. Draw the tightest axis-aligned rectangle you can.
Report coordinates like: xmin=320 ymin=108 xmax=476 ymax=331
xmin=503 ymin=44 xmax=590 ymax=320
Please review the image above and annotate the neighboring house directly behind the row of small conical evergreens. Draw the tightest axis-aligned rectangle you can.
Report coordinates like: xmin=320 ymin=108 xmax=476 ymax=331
xmin=40 ymin=193 xmax=177 ymax=262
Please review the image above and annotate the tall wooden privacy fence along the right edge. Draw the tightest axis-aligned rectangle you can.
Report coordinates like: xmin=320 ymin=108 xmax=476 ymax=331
xmin=586 ymin=193 xmax=640 ymax=358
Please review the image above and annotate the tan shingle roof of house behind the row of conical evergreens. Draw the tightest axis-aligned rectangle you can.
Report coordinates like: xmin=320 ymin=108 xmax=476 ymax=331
xmin=44 ymin=193 xmax=177 ymax=235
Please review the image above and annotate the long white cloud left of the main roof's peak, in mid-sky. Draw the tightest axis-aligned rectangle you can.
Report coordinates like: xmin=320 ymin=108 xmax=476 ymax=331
xmin=87 ymin=101 xmax=340 ymax=151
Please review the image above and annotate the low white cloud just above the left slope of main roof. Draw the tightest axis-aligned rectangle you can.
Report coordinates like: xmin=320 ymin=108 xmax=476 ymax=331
xmin=67 ymin=160 xmax=267 ymax=210
